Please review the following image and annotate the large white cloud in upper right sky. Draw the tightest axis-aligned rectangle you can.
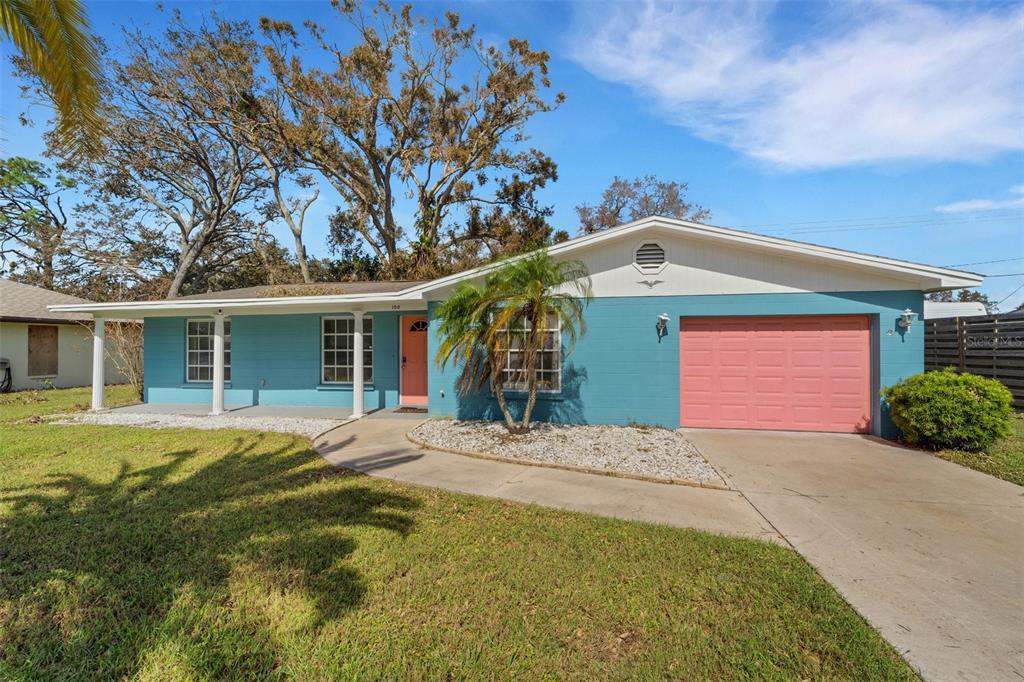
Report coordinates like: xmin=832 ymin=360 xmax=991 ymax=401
xmin=570 ymin=2 xmax=1024 ymax=168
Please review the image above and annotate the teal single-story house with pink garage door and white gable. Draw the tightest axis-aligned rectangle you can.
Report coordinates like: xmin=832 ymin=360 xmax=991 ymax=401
xmin=55 ymin=217 xmax=982 ymax=436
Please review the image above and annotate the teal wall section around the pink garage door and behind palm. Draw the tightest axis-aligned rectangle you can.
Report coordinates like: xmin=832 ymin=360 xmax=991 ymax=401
xmin=428 ymin=291 xmax=924 ymax=437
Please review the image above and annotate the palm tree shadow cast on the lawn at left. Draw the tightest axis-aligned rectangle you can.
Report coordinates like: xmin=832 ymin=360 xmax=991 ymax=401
xmin=0 ymin=436 xmax=418 ymax=679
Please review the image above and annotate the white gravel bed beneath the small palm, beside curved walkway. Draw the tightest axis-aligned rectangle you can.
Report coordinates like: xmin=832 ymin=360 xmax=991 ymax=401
xmin=412 ymin=419 xmax=724 ymax=484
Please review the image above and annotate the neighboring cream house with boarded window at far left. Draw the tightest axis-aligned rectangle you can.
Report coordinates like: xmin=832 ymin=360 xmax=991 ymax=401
xmin=0 ymin=280 xmax=120 ymax=390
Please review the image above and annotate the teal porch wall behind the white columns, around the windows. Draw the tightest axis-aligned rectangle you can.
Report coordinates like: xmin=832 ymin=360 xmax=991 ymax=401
xmin=143 ymin=311 xmax=416 ymax=410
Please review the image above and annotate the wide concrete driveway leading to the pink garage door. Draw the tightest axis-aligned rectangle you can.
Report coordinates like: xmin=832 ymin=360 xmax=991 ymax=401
xmin=684 ymin=429 xmax=1024 ymax=682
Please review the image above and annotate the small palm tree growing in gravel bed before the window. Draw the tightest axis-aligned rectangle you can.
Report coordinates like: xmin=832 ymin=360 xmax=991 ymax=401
xmin=436 ymin=251 xmax=591 ymax=431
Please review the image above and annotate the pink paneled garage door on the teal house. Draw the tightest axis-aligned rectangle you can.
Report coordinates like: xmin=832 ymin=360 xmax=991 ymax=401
xmin=679 ymin=315 xmax=871 ymax=432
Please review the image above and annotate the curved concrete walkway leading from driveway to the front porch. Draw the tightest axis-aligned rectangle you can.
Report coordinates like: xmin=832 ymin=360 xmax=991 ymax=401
xmin=313 ymin=417 xmax=784 ymax=542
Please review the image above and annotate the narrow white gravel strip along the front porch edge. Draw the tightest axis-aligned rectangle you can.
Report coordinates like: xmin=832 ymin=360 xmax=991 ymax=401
xmin=50 ymin=412 xmax=346 ymax=439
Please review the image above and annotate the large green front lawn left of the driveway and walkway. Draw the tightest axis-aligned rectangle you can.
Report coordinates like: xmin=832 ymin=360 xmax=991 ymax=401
xmin=0 ymin=391 xmax=913 ymax=680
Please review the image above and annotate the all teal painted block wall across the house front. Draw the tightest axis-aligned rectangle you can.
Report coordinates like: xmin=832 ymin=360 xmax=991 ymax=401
xmin=144 ymin=291 xmax=924 ymax=437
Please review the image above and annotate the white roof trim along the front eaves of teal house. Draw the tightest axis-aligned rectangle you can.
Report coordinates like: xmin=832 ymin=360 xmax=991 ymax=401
xmin=47 ymin=216 xmax=984 ymax=317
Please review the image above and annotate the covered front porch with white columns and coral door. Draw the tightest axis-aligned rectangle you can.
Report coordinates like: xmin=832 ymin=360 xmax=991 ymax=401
xmin=47 ymin=283 xmax=429 ymax=420
